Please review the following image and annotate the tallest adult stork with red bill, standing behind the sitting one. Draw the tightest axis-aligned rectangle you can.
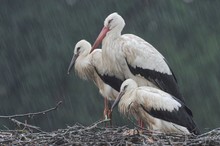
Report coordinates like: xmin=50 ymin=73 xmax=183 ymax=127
xmin=91 ymin=13 xmax=184 ymax=102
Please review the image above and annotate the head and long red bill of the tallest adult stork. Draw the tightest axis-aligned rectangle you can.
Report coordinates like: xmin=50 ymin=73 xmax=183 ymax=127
xmin=91 ymin=12 xmax=125 ymax=52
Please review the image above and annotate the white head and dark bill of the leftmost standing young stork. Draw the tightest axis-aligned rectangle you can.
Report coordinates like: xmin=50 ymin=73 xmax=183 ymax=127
xmin=67 ymin=40 xmax=91 ymax=74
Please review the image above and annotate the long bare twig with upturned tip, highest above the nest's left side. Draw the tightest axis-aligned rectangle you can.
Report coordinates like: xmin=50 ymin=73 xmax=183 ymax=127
xmin=0 ymin=101 xmax=62 ymax=119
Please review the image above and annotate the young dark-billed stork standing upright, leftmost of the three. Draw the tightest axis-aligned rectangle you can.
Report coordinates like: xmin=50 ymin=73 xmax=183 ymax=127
xmin=68 ymin=40 xmax=118 ymax=122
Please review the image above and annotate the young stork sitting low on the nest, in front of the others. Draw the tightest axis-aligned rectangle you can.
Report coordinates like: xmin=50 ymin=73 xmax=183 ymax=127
xmin=112 ymin=79 xmax=199 ymax=135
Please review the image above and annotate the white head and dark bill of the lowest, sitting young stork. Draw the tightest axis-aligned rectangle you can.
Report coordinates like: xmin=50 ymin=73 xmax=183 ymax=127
xmin=111 ymin=79 xmax=138 ymax=111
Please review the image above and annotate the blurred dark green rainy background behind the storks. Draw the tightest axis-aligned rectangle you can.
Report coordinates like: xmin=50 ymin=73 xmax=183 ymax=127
xmin=0 ymin=0 xmax=220 ymax=131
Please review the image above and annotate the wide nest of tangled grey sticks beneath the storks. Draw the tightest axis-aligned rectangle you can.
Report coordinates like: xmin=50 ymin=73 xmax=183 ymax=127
xmin=0 ymin=121 xmax=220 ymax=146
